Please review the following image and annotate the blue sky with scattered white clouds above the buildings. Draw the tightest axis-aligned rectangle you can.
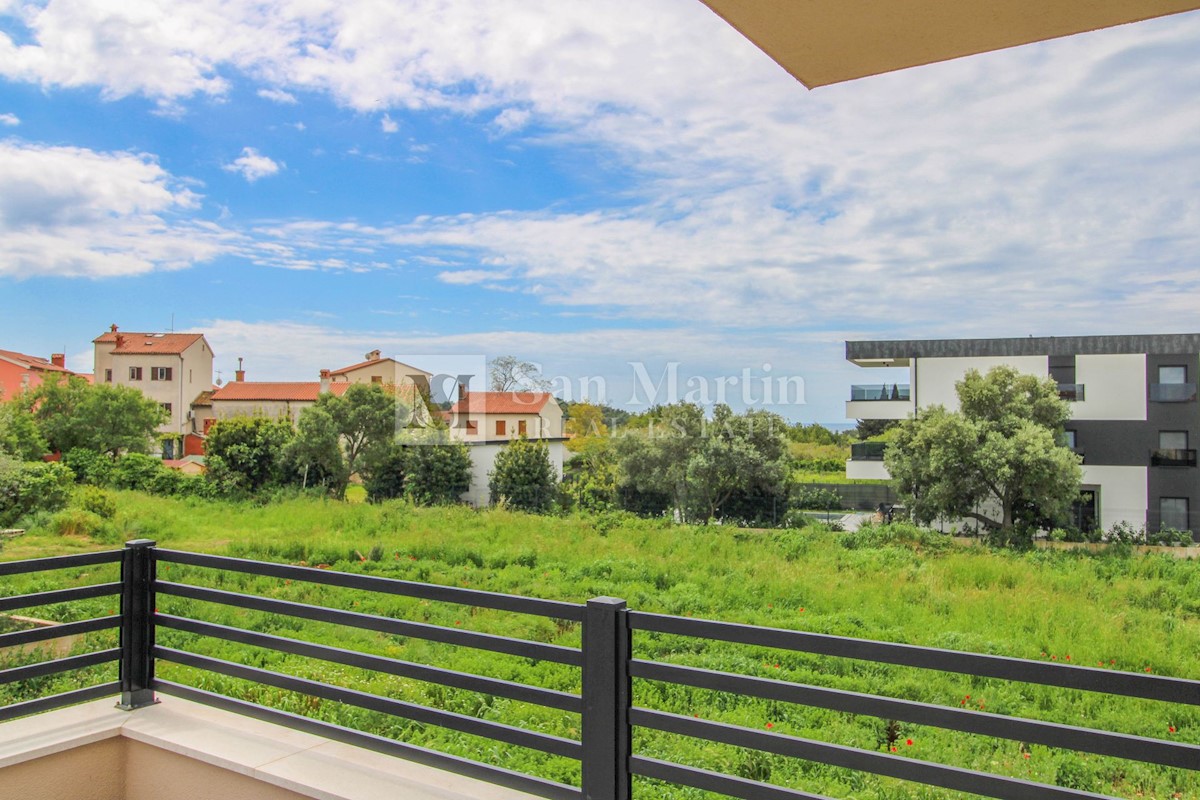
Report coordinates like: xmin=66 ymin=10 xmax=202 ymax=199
xmin=0 ymin=0 xmax=1200 ymax=422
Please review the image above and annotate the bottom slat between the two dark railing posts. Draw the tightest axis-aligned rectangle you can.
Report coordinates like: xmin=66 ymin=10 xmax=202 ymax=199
xmin=154 ymin=678 xmax=582 ymax=800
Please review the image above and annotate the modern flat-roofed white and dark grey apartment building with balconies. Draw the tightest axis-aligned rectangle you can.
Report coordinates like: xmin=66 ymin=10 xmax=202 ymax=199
xmin=846 ymin=333 xmax=1200 ymax=531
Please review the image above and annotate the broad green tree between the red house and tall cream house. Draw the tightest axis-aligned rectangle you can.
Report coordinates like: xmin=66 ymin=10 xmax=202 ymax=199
xmin=22 ymin=375 xmax=169 ymax=458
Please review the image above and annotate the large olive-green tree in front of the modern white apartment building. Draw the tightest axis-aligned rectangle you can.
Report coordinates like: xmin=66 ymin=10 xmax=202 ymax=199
xmin=883 ymin=366 xmax=1081 ymax=530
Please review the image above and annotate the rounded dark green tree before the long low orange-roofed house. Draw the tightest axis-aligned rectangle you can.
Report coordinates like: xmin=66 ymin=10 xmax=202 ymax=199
xmin=205 ymin=416 xmax=294 ymax=493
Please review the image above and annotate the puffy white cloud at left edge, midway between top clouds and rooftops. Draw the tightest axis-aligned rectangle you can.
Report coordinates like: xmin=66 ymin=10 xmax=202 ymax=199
xmin=0 ymin=140 xmax=233 ymax=278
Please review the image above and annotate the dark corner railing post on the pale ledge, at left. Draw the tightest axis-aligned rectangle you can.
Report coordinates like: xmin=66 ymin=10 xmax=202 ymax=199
xmin=116 ymin=539 xmax=158 ymax=711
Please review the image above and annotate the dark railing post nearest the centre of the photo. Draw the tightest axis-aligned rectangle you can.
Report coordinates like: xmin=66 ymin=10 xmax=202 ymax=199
xmin=582 ymin=597 xmax=631 ymax=800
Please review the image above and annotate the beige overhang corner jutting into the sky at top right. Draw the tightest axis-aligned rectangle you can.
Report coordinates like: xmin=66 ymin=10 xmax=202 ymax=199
xmin=703 ymin=0 xmax=1200 ymax=89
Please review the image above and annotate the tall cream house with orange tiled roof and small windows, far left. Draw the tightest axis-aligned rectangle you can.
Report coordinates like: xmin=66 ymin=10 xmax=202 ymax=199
xmin=92 ymin=325 xmax=212 ymax=457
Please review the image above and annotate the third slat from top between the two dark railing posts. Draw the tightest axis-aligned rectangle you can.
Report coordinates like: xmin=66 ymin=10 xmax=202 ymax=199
xmin=155 ymin=614 xmax=583 ymax=714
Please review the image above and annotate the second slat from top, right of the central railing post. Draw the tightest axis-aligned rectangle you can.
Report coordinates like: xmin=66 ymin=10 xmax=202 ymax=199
xmin=630 ymin=661 xmax=1200 ymax=770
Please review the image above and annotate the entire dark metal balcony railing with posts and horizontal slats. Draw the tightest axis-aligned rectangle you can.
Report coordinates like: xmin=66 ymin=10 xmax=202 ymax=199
xmin=0 ymin=540 xmax=1200 ymax=800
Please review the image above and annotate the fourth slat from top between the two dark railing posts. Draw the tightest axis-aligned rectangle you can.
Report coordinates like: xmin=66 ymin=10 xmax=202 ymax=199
xmin=154 ymin=646 xmax=582 ymax=759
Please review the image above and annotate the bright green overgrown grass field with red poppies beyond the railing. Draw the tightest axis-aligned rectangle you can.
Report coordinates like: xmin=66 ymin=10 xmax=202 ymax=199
xmin=0 ymin=493 xmax=1200 ymax=799
